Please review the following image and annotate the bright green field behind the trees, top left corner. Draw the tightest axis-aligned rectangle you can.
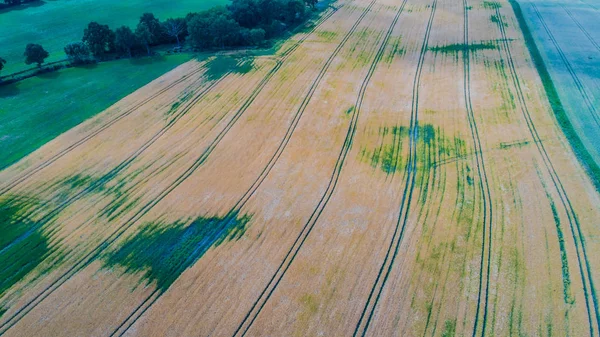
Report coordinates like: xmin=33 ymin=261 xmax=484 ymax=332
xmin=0 ymin=0 xmax=228 ymax=75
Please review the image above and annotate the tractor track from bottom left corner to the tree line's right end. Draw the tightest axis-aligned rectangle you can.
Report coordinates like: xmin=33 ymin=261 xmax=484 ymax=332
xmin=0 ymin=8 xmax=337 ymax=335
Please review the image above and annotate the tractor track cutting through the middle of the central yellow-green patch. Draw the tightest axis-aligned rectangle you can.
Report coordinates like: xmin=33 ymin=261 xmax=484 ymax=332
xmin=353 ymin=0 xmax=437 ymax=336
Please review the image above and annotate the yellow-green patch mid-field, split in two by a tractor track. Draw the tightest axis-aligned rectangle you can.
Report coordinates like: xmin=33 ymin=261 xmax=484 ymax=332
xmin=360 ymin=124 xmax=466 ymax=173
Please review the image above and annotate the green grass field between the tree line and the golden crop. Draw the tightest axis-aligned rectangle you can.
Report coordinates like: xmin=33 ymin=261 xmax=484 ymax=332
xmin=0 ymin=53 xmax=192 ymax=169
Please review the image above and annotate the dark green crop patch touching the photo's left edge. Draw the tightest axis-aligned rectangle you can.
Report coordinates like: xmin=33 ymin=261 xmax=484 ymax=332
xmin=0 ymin=197 xmax=51 ymax=297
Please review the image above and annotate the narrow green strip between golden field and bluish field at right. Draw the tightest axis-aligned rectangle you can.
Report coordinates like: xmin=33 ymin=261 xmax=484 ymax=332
xmin=509 ymin=0 xmax=600 ymax=191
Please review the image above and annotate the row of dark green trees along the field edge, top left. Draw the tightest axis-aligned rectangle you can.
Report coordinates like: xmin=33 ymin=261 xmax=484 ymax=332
xmin=0 ymin=0 xmax=318 ymax=77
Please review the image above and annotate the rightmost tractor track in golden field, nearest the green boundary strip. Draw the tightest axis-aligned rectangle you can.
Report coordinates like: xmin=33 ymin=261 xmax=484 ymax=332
xmin=495 ymin=0 xmax=600 ymax=336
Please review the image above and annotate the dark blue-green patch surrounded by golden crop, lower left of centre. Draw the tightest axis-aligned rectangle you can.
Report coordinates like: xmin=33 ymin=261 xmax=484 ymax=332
xmin=104 ymin=212 xmax=250 ymax=292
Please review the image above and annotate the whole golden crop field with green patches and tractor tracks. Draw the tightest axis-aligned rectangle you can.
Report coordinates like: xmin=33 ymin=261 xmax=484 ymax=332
xmin=0 ymin=0 xmax=600 ymax=336
